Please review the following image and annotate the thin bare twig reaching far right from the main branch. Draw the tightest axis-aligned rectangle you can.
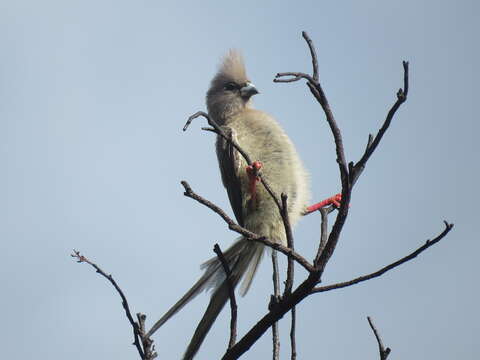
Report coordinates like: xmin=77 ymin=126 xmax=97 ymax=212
xmin=312 ymin=221 xmax=453 ymax=294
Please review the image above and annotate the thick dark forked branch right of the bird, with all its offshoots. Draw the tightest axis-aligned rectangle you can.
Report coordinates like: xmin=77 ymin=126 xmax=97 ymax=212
xmin=222 ymin=32 xmax=453 ymax=360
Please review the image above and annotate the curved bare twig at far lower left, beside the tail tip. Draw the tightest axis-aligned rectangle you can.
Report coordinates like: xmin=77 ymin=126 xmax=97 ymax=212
xmin=70 ymin=249 xmax=157 ymax=360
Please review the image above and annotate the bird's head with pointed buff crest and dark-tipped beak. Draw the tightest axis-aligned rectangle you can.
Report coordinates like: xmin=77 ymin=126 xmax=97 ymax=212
xmin=207 ymin=50 xmax=258 ymax=123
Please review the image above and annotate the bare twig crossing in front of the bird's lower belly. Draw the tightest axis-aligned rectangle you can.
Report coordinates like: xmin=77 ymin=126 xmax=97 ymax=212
xmin=181 ymin=181 xmax=314 ymax=272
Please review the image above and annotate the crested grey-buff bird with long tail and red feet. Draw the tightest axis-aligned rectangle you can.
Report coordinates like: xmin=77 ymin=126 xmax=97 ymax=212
xmin=149 ymin=50 xmax=338 ymax=360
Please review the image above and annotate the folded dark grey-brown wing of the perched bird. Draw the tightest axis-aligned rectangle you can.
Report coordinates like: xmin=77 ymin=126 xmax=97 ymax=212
xmin=217 ymin=126 xmax=248 ymax=226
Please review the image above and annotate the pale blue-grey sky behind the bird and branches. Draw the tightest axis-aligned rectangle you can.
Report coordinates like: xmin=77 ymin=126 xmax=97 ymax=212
xmin=0 ymin=0 xmax=480 ymax=360
